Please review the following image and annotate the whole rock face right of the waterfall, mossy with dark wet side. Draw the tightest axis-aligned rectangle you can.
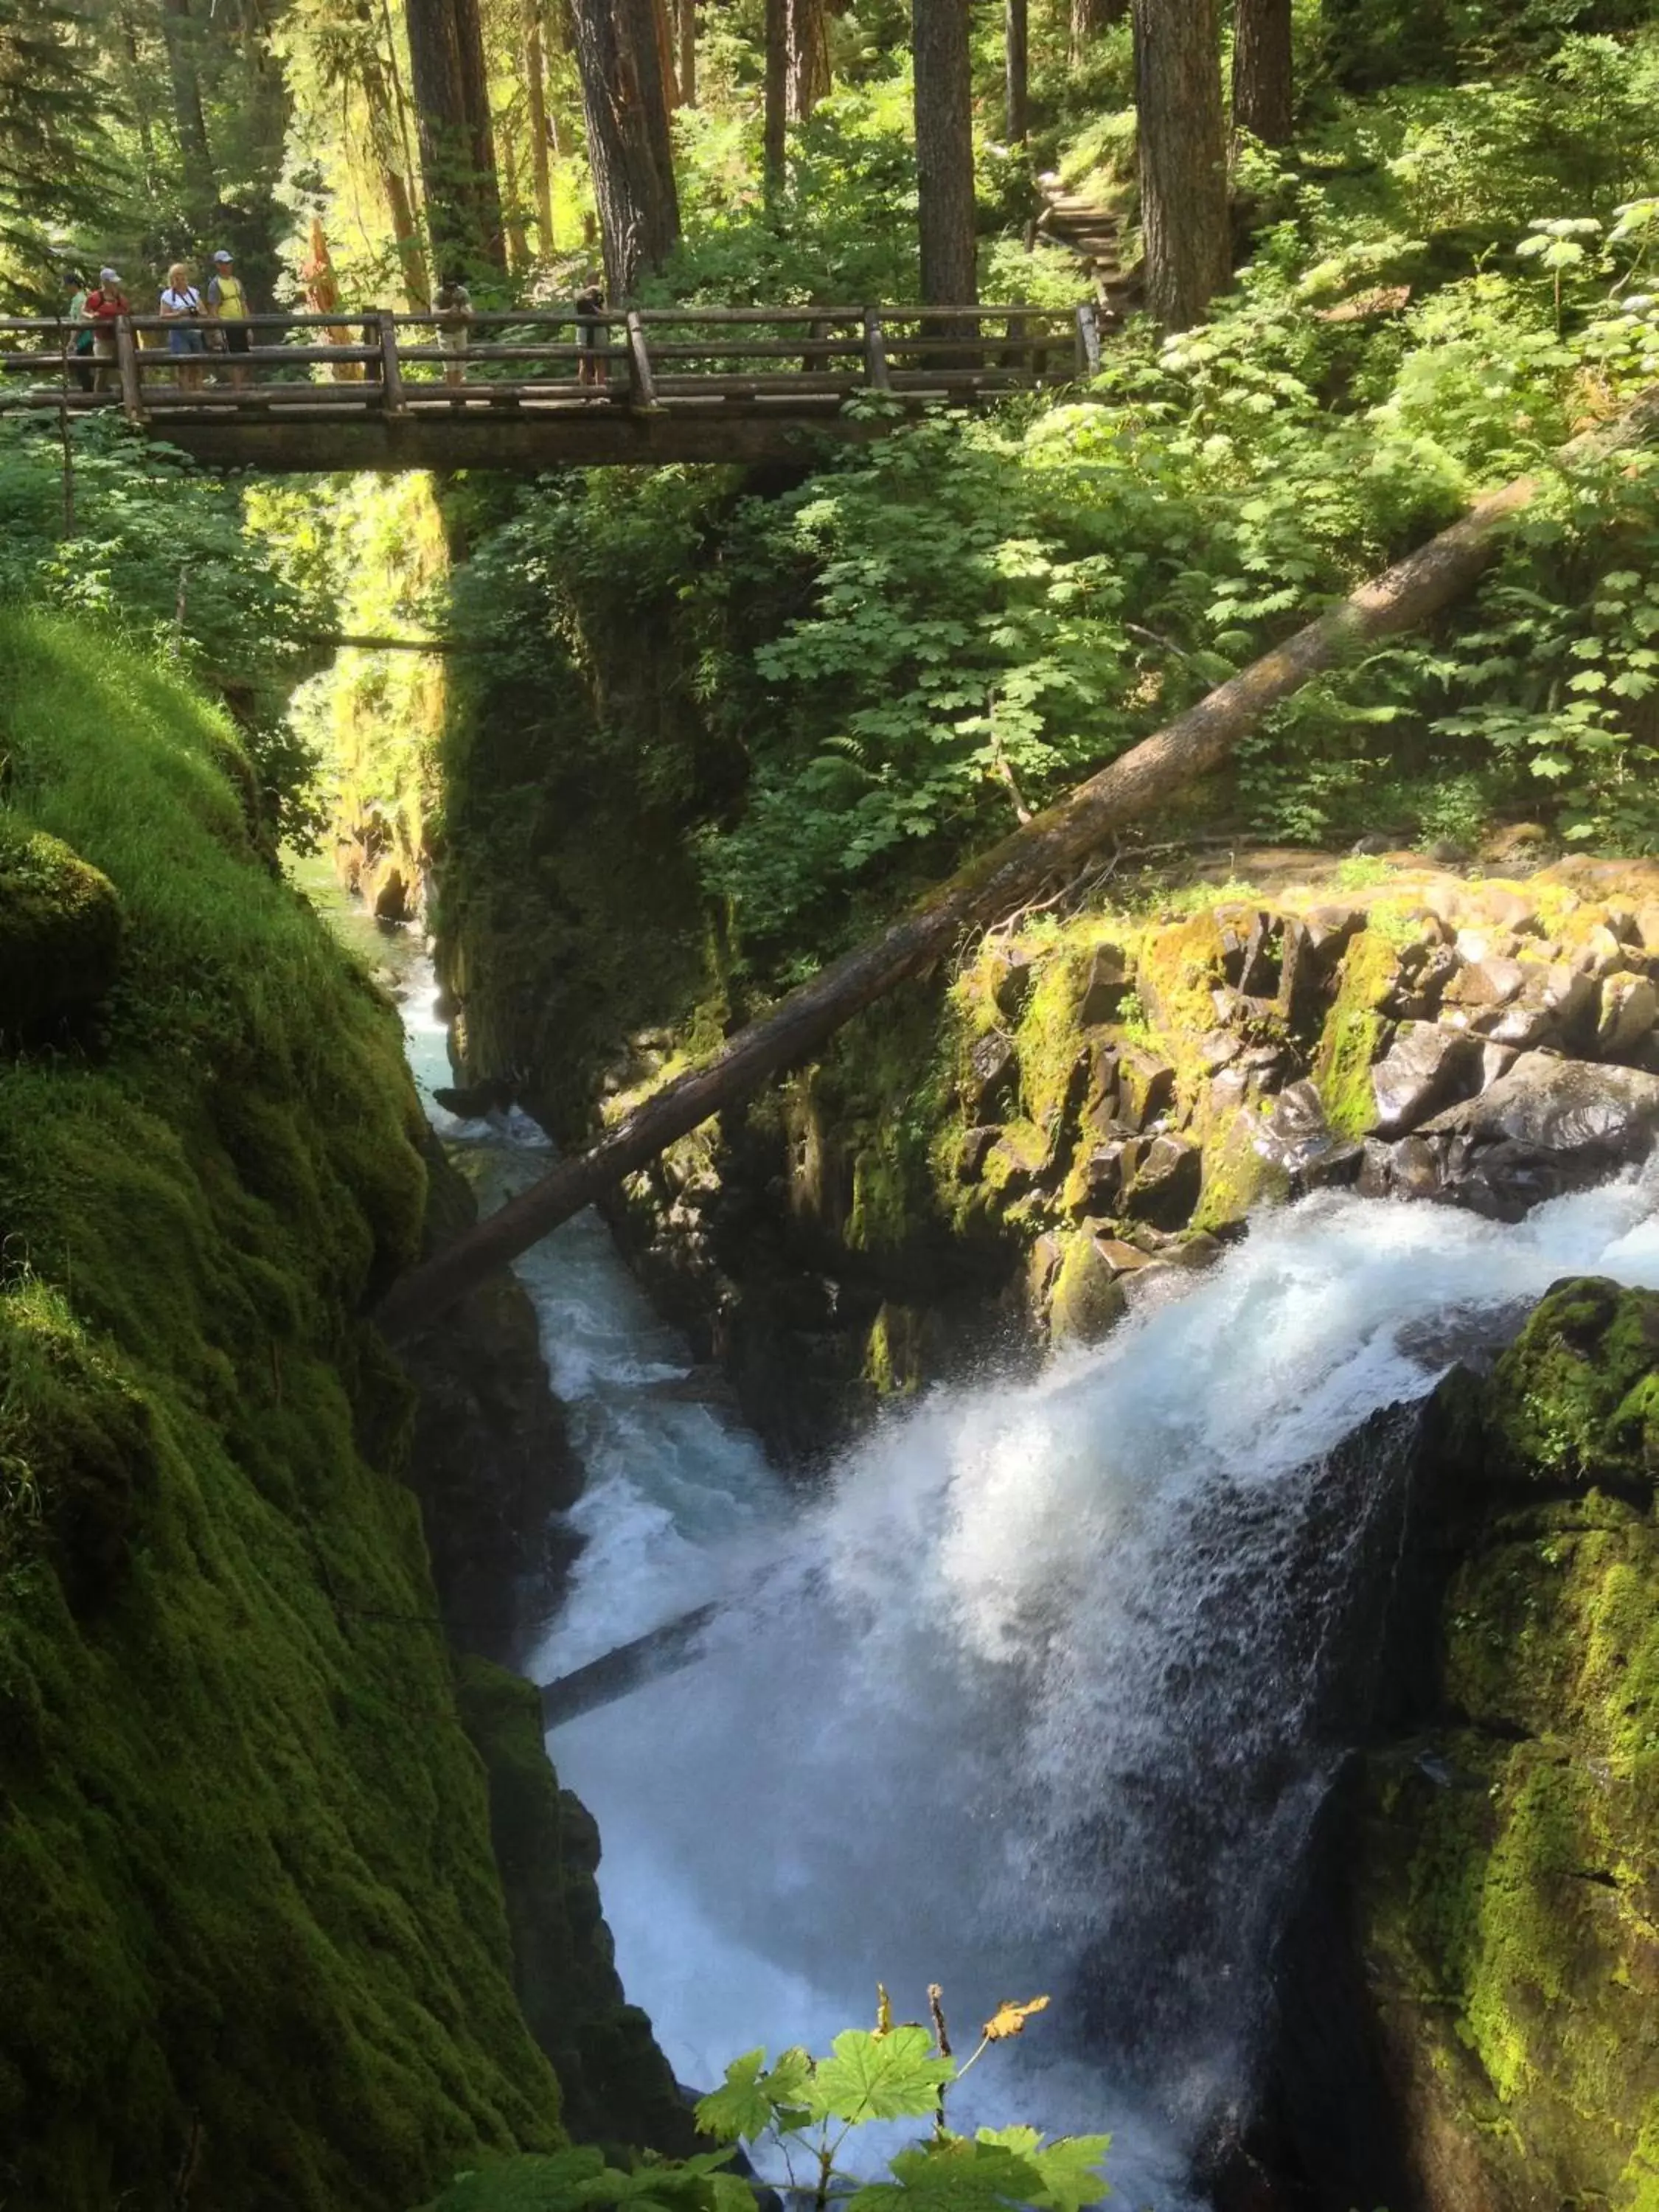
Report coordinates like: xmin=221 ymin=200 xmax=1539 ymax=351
xmin=1274 ymin=1281 xmax=1659 ymax=2212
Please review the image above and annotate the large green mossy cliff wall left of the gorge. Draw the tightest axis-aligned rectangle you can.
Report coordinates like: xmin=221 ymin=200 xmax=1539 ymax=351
xmin=0 ymin=615 xmax=677 ymax=2212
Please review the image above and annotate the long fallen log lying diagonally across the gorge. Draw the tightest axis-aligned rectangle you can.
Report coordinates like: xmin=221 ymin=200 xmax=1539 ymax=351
xmin=376 ymin=392 xmax=1659 ymax=1343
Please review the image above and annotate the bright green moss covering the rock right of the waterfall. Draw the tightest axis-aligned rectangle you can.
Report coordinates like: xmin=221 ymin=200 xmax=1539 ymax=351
xmin=1356 ymin=1281 xmax=1659 ymax=2208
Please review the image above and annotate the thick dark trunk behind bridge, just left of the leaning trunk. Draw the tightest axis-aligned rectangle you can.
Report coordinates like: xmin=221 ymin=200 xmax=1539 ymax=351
xmin=403 ymin=0 xmax=507 ymax=276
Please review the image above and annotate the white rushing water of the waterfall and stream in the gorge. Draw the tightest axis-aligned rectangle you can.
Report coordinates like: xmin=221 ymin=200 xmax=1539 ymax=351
xmin=319 ymin=885 xmax=1659 ymax=2205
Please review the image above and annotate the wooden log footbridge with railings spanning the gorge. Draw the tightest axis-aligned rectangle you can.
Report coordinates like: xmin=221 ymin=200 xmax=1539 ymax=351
xmin=0 ymin=307 xmax=1099 ymax=473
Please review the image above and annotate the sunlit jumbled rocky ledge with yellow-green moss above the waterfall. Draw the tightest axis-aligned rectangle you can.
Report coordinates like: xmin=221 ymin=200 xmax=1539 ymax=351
xmin=604 ymin=854 xmax=1659 ymax=1455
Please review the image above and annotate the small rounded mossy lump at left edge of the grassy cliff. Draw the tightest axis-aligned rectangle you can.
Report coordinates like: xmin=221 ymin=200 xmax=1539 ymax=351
xmin=0 ymin=812 xmax=122 ymax=1042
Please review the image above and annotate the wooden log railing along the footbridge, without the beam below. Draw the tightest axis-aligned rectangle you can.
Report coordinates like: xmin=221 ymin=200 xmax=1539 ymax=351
xmin=0 ymin=305 xmax=1099 ymax=420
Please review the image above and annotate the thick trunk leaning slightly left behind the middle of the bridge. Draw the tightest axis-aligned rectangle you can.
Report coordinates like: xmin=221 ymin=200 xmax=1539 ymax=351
xmin=571 ymin=0 xmax=679 ymax=303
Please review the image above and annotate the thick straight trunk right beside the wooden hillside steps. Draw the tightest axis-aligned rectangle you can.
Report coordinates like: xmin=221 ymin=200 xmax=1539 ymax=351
xmin=1135 ymin=0 xmax=1228 ymax=330
